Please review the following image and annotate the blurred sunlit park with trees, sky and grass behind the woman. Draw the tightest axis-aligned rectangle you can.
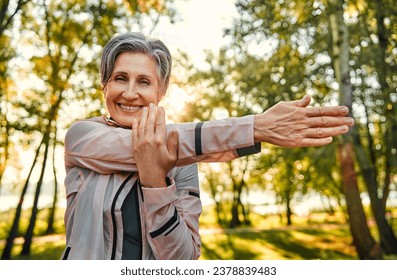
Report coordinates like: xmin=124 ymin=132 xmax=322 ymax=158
xmin=0 ymin=0 xmax=397 ymax=260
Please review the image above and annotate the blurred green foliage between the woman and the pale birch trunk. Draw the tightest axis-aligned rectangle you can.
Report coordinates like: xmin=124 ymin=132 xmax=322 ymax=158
xmin=178 ymin=1 xmax=341 ymax=225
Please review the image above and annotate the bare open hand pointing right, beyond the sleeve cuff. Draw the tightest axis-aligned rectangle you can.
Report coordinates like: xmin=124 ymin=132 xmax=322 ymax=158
xmin=254 ymin=95 xmax=354 ymax=148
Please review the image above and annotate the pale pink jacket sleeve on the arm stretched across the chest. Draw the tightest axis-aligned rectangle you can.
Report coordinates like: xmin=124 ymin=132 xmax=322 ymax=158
xmin=65 ymin=115 xmax=261 ymax=174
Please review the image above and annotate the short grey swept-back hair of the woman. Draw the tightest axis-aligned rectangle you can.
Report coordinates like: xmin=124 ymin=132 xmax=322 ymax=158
xmin=100 ymin=32 xmax=172 ymax=94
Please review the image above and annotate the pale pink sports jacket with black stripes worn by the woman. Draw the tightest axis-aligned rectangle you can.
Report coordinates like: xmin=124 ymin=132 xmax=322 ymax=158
xmin=62 ymin=116 xmax=260 ymax=259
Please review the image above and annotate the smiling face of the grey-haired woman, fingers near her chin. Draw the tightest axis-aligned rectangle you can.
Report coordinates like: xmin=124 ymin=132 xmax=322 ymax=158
xmin=104 ymin=52 xmax=163 ymax=127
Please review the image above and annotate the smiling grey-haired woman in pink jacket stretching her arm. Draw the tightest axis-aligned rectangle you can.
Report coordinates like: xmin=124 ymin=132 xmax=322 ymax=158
xmin=63 ymin=33 xmax=353 ymax=259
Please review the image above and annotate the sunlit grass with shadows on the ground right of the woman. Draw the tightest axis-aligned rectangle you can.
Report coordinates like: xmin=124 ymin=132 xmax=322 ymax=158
xmin=201 ymin=226 xmax=357 ymax=260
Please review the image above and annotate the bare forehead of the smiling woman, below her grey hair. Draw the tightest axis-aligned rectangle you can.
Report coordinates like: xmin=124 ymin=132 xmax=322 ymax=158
xmin=113 ymin=52 xmax=157 ymax=77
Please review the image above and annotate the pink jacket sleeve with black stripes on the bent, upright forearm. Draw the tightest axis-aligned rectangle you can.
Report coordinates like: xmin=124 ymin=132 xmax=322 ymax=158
xmin=142 ymin=164 xmax=202 ymax=260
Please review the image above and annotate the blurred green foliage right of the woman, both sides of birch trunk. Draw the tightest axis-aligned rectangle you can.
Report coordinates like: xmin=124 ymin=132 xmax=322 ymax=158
xmin=177 ymin=0 xmax=397 ymax=235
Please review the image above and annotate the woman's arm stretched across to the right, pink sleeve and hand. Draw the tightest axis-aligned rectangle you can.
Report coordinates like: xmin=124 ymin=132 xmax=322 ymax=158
xmin=65 ymin=96 xmax=354 ymax=174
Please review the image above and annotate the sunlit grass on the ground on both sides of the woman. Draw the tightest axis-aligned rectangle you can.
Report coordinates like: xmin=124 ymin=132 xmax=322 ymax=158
xmin=0 ymin=225 xmax=357 ymax=260
